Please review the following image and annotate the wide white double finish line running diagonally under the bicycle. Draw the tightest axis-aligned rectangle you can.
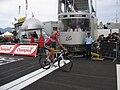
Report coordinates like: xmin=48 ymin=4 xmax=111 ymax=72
xmin=0 ymin=61 xmax=69 ymax=90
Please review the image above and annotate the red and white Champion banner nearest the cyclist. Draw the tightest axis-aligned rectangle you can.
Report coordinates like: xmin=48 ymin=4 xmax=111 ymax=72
xmin=14 ymin=44 xmax=38 ymax=56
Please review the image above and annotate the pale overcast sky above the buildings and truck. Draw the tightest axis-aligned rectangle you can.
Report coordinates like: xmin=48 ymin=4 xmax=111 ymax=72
xmin=0 ymin=0 xmax=120 ymax=28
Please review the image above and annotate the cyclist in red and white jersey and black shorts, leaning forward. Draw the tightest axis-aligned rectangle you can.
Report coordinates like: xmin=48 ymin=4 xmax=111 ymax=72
xmin=45 ymin=31 xmax=67 ymax=62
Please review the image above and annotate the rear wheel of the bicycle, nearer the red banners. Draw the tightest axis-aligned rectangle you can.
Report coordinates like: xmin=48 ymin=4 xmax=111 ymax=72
xmin=39 ymin=57 xmax=51 ymax=69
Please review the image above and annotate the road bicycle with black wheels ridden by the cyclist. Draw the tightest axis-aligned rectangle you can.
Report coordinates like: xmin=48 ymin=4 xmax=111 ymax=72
xmin=39 ymin=49 xmax=73 ymax=72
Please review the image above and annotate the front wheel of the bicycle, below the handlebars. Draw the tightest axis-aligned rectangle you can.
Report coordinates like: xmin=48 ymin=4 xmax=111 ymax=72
xmin=58 ymin=56 xmax=73 ymax=72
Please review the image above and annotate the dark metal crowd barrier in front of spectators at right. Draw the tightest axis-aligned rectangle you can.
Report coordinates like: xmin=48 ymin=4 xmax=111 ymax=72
xmin=100 ymin=42 xmax=119 ymax=62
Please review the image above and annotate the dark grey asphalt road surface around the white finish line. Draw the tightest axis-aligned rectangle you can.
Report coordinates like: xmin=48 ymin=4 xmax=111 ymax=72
xmin=0 ymin=55 xmax=120 ymax=90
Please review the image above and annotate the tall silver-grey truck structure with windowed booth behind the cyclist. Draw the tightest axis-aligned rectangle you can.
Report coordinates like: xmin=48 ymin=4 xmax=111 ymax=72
xmin=58 ymin=0 xmax=97 ymax=56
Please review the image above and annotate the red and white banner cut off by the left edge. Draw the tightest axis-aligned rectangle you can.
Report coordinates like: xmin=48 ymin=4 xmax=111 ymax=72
xmin=0 ymin=44 xmax=15 ymax=54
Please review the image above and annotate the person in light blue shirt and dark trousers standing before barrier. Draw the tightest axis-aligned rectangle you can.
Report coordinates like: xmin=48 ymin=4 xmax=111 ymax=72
xmin=84 ymin=33 xmax=94 ymax=59
